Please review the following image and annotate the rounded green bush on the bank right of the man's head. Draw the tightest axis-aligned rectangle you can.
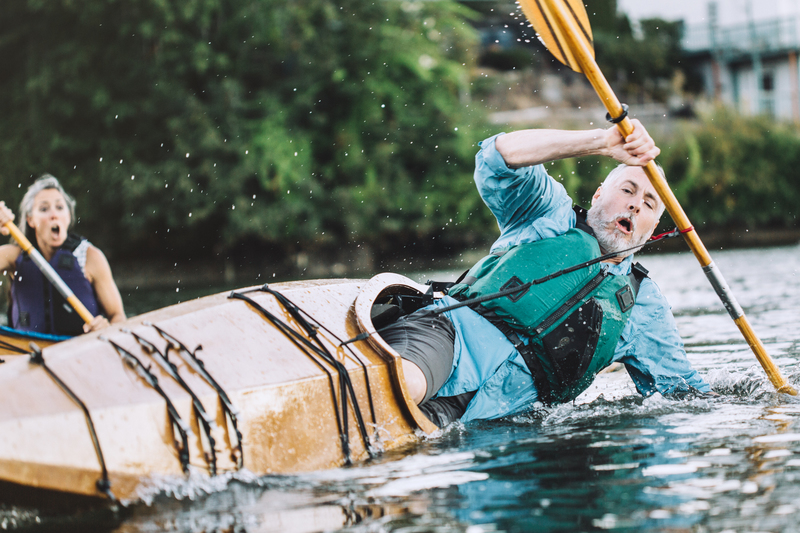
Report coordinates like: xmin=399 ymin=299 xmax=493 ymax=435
xmin=660 ymin=110 xmax=800 ymax=229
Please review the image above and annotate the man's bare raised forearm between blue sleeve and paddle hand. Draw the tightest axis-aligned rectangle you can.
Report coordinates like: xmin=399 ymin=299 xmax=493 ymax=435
xmin=495 ymin=129 xmax=608 ymax=168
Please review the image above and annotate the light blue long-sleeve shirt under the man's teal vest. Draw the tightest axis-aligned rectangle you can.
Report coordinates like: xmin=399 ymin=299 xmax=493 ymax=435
xmin=435 ymin=132 xmax=711 ymax=422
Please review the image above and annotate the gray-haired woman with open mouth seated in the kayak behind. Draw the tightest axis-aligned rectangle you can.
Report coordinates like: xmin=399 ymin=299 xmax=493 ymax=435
xmin=0 ymin=174 xmax=125 ymax=335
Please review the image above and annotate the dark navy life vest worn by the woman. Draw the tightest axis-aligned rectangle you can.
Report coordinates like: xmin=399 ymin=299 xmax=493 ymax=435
xmin=9 ymin=233 xmax=100 ymax=335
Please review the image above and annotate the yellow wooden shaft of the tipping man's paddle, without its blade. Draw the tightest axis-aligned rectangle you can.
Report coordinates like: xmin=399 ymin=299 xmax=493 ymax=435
xmin=545 ymin=0 xmax=797 ymax=396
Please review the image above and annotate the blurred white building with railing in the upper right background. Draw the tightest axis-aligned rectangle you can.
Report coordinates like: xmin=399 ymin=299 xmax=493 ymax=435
xmin=682 ymin=0 xmax=800 ymax=122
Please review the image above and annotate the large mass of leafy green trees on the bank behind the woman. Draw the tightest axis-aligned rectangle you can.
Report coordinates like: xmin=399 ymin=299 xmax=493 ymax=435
xmin=0 ymin=0 xmax=488 ymax=262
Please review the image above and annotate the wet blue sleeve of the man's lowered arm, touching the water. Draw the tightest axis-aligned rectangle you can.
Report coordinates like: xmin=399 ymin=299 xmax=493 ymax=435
xmin=614 ymin=278 xmax=711 ymax=396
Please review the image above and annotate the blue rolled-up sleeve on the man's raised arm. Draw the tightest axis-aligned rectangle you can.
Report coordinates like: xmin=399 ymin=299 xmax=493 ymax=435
xmin=475 ymin=133 xmax=575 ymax=252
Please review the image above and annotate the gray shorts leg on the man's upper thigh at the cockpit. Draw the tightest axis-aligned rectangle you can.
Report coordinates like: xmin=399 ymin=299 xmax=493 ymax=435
xmin=380 ymin=309 xmax=456 ymax=403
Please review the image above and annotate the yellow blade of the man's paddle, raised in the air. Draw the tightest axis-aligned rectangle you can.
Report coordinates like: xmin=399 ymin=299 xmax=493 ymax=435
xmin=517 ymin=0 xmax=594 ymax=72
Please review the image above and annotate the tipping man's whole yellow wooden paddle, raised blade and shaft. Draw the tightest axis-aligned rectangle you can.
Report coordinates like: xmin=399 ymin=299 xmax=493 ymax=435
xmin=518 ymin=0 xmax=797 ymax=396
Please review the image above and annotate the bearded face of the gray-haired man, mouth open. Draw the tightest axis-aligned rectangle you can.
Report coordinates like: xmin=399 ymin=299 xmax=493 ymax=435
xmin=586 ymin=167 xmax=661 ymax=259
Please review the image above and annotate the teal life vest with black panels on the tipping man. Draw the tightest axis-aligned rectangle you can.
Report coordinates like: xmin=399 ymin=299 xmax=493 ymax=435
xmin=448 ymin=218 xmax=647 ymax=404
